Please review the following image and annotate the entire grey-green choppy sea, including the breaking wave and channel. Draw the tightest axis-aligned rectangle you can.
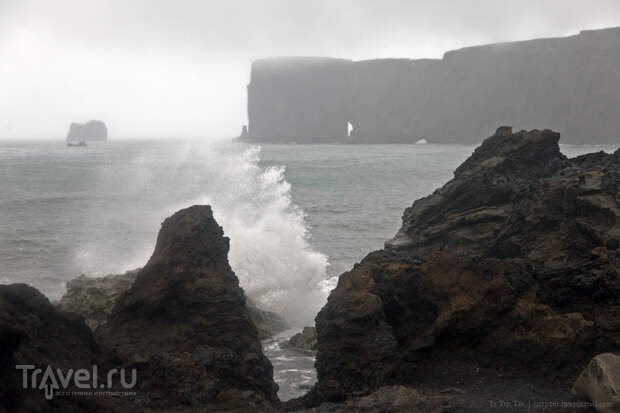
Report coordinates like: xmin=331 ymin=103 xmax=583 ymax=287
xmin=0 ymin=139 xmax=616 ymax=399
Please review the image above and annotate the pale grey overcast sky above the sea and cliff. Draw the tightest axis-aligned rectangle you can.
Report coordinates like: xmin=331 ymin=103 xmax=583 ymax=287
xmin=0 ymin=0 xmax=620 ymax=138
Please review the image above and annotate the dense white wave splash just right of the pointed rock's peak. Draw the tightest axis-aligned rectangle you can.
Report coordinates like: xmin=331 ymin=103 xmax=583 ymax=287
xmin=179 ymin=143 xmax=328 ymax=324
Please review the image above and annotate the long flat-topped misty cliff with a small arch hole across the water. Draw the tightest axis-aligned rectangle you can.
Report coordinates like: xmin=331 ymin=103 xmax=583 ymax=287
xmin=248 ymin=28 xmax=620 ymax=144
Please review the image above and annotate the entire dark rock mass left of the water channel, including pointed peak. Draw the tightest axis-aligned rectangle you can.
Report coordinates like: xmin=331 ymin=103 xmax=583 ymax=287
xmin=0 ymin=206 xmax=277 ymax=412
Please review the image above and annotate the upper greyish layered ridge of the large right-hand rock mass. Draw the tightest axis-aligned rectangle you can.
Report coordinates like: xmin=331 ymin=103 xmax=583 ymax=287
xmin=386 ymin=128 xmax=620 ymax=268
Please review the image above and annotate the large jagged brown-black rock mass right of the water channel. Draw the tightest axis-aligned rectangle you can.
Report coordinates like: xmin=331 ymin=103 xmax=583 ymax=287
xmin=305 ymin=127 xmax=620 ymax=404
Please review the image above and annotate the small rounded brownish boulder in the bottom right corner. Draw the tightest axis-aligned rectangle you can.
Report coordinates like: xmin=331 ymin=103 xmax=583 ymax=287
xmin=573 ymin=353 xmax=620 ymax=413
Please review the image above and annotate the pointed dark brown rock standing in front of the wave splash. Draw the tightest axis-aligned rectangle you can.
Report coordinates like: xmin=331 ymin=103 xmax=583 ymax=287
xmin=98 ymin=206 xmax=277 ymax=411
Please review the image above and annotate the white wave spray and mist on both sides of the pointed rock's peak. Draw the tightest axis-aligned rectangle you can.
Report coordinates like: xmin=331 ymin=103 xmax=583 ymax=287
xmin=76 ymin=141 xmax=329 ymax=325
